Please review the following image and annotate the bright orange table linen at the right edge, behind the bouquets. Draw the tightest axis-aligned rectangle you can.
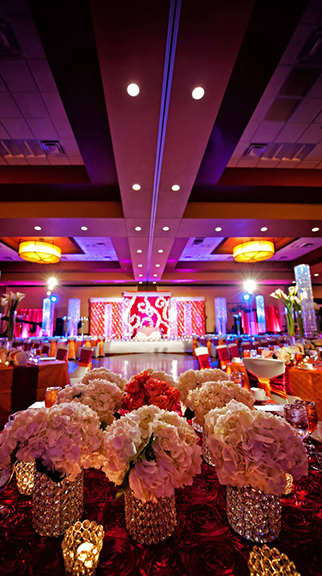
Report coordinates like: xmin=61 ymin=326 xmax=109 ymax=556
xmin=289 ymin=366 xmax=322 ymax=420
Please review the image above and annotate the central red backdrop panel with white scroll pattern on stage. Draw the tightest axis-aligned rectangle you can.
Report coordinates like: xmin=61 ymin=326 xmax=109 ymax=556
xmin=124 ymin=292 xmax=171 ymax=338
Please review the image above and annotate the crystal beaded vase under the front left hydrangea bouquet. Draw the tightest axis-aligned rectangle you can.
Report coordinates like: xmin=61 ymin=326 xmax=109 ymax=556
xmin=32 ymin=472 xmax=84 ymax=537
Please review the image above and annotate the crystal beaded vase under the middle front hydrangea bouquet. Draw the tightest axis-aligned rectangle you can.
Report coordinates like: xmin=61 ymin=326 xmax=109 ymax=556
xmin=124 ymin=490 xmax=177 ymax=545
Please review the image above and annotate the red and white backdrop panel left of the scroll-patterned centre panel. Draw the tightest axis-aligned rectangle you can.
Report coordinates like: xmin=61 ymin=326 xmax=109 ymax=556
xmin=90 ymin=298 xmax=124 ymax=340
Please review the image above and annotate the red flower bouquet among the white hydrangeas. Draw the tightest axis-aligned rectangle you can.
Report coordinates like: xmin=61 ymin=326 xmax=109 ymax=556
xmin=122 ymin=369 xmax=180 ymax=410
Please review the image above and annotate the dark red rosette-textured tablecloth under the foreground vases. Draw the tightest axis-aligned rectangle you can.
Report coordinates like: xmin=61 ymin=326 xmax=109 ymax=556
xmin=0 ymin=454 xmax=322 ymax=576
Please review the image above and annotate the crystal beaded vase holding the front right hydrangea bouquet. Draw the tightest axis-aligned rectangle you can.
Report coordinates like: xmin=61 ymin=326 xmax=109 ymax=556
xmin=227 ymin=486 xmax=282 ymax=542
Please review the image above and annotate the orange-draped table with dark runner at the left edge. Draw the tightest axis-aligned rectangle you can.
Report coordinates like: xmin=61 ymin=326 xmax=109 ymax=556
xmin=0 ymin=360 xmax=69 ymax=429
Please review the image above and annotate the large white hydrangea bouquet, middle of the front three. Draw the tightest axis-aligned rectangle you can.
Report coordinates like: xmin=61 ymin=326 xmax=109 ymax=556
xmin=103 ymin=405 xmax=201 ymax=502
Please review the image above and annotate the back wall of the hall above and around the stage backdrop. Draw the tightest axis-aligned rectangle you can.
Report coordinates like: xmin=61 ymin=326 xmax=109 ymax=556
xmin=3 ymin=285 xmax=296 ymax=332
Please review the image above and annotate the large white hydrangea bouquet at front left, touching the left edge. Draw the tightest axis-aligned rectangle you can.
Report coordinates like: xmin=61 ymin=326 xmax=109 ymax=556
xmin=0 ymin=402 xmax=104 ymax=482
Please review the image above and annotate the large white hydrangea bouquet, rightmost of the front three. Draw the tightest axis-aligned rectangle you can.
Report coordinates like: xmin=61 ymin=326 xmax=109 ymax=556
xmin=205 ymin=400 xmax=308 ymax=496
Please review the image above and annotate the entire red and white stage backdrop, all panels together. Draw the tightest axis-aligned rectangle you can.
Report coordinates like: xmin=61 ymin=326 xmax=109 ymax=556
xmin=90 ymin=292 xmax=205 ymax=339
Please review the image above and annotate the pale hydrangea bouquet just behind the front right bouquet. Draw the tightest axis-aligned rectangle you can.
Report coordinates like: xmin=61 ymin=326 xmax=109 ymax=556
xmin=186 ymin=380 xmax=254 ymax=427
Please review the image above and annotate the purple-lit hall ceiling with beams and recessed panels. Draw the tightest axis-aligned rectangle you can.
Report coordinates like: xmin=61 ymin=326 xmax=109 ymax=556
xmin=0 ymin=0 xmax=322 ymax=285
